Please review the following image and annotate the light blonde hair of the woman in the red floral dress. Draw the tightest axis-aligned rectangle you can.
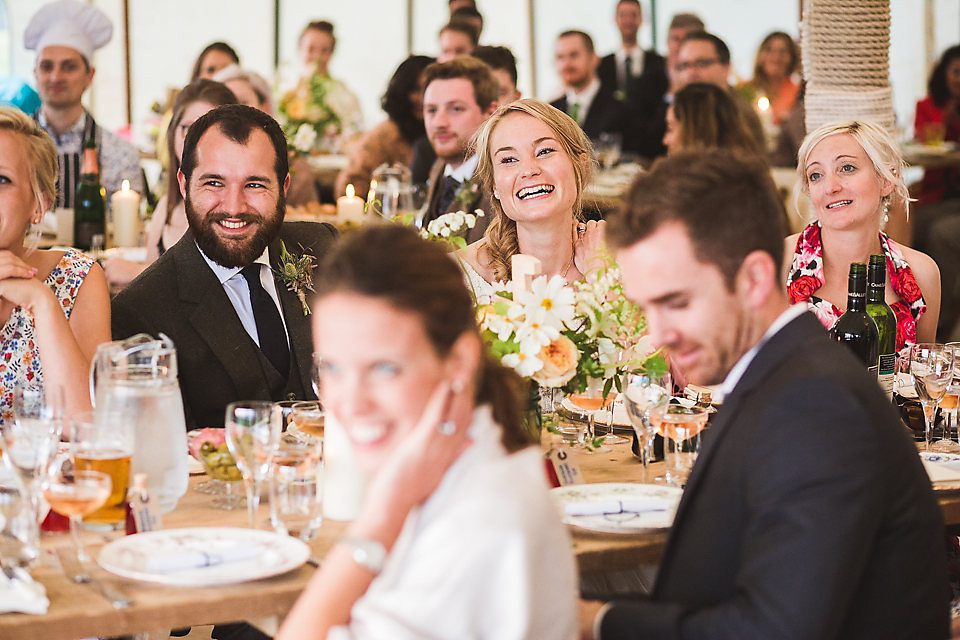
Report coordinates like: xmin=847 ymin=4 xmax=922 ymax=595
xmin=795 ymin=120 xmax=911 ymax=224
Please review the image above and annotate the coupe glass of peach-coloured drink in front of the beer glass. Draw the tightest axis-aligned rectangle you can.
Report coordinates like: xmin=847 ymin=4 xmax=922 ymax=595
xmin=42 ymin=462 xmax=112 ymax=582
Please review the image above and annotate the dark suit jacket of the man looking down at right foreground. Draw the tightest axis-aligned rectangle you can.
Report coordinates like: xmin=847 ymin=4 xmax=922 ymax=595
xmin=600 ymin=313 xmax=950 ymax=640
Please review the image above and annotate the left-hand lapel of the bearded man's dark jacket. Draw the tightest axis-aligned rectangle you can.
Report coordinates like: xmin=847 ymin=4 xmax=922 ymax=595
xmin=170 ymin=231 xmax=267 ymax=396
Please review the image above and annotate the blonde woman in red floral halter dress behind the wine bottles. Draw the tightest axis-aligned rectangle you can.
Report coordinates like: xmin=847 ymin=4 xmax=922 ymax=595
xmin=784 ymin=121 xmax=940 ymax=350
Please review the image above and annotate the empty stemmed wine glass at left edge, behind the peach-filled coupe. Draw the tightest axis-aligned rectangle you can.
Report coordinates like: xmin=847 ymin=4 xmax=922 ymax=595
xmin=3 ymin=386 xmax=63 ymax=550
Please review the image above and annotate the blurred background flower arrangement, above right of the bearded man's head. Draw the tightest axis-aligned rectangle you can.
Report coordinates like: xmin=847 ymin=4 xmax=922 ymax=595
xmin=277 ymin=73 xmax=360 ymax=155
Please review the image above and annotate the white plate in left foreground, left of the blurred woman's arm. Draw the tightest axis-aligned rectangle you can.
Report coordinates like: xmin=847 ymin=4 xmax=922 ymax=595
xmin=97 ymin=527 xmax=310 ymax=587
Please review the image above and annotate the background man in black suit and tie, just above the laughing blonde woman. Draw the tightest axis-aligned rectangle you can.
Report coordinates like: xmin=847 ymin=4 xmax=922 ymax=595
xmin=550 ymin=30 xmax=628 ymax=151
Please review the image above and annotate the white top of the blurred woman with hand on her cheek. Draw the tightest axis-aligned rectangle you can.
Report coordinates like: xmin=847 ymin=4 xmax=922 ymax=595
xmin=327 ymin=406 xmax=577 ymax=640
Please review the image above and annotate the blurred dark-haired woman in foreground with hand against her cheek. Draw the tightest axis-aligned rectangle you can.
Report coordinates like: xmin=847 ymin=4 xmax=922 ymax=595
xmin=277 ymin=225 xmax=577 ymax=640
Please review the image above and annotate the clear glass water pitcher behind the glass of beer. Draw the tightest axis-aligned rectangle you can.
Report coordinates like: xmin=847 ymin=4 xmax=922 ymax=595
xmin=90 ymin=333 xmax=187 ymax=513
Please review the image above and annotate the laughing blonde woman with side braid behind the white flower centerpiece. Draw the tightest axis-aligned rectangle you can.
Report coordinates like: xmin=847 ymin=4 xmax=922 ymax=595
xmin=457 ymin=99 xmax=605 ymax=293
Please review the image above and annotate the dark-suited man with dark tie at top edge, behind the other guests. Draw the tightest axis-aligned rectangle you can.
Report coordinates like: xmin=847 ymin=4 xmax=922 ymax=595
xmin=597 ymin=0 xmax=669 ymax=158
